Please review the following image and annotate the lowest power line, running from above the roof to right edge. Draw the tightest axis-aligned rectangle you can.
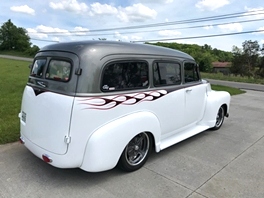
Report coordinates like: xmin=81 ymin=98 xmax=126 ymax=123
xmin=131 ymin=30 xmax=264 ymax=43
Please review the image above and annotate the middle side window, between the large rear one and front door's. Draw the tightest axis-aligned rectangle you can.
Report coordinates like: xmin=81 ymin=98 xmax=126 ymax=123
xmin=153 ymin=62 xmax=181 ymax=86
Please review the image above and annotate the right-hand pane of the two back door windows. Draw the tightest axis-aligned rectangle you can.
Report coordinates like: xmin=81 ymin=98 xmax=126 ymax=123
xmin=46 ymin=60 xmax=71 ymax=82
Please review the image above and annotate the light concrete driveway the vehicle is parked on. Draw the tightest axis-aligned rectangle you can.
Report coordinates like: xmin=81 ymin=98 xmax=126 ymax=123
xmin=0 ymin=91 xmax=264 ymax=198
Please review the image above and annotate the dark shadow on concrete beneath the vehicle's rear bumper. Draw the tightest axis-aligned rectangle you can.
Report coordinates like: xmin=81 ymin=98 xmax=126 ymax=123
xmin=17 ymin=145 xmax=135 ymax=187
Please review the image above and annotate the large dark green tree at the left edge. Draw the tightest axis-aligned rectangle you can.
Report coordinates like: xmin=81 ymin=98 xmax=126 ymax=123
xmin=0 ymin=19 xmax=31 ymax=51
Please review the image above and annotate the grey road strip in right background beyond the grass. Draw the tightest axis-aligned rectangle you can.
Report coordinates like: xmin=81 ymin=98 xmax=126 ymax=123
xmin=207 ymin=79 xmax=264 ymax=91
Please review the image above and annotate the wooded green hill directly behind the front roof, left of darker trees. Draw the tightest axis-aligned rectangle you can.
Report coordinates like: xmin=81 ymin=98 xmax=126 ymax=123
xmin=148 ymin=42 xmax=233 ymax=72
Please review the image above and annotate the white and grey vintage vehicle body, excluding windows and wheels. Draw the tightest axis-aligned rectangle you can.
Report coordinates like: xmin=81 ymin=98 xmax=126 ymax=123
xmin=19 ymin=42 xmax=230 ymax=172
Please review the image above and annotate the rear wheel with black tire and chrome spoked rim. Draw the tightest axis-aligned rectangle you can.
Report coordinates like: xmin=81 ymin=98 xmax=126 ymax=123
xmin=118 ymin=132 xmax=152 ymax=172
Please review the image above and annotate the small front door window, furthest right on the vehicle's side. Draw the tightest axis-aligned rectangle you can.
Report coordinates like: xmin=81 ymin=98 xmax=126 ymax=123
xmin=184 ymin=63 xmax=200 ymax=83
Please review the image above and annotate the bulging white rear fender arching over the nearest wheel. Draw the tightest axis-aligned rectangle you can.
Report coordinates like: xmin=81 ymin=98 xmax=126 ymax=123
xmin=80 ymin=112 xmax=161 ymax=172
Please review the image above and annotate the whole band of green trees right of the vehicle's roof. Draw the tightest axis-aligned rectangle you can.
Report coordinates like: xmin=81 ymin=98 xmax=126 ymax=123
xmin=148 ymin=40 xmax=264 ymax=81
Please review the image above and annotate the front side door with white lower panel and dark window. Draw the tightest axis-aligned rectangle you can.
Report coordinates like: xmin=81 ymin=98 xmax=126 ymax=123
xmin=183 ymin=62 xmax=206 ymax=126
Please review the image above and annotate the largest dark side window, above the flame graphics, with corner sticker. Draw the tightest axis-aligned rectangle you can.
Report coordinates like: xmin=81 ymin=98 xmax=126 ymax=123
xmin=101 ymin=61 xmax=149 ymax=91
